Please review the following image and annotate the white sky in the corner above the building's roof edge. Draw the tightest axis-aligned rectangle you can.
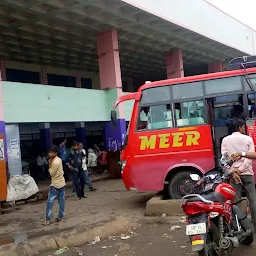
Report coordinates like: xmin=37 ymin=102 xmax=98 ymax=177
xmin=206 ymin=0 xmax=256 ymax=29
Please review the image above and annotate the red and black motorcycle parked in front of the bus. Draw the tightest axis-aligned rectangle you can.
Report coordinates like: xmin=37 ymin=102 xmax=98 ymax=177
xmin=181 ymin=155 xmax=254 ymax=256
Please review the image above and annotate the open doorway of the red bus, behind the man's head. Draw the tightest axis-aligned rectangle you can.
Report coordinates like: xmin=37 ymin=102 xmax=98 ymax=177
xmin=207 ymin=94 xmax=244 ymax=166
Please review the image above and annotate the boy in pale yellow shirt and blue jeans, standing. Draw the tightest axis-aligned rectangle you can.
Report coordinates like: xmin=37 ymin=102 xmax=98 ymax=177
xmin=44 ymin=146 xmax=66 ymax=225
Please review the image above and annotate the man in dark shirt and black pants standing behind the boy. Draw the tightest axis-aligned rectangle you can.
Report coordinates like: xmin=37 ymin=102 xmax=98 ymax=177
xmin=67 ymin=141 xmax=86 ymax=200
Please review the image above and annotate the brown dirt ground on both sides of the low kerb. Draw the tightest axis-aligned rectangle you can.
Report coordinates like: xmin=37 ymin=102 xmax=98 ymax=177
xmin=0 ymin=180 xmax=256 ymax=256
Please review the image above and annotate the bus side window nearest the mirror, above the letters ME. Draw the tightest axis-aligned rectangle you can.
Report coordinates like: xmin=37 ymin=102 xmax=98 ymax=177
xmin=138 ymin=104 xmax=173 ymax=131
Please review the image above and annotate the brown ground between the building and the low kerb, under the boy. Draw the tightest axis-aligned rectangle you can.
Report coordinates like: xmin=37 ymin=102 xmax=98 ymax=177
xmin=0 ymin=180 xmax=152 ymax=245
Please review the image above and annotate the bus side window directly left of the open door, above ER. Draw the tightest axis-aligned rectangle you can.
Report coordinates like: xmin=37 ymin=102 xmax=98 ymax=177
xmin=175 ymin=100 xmax=206 ymax=126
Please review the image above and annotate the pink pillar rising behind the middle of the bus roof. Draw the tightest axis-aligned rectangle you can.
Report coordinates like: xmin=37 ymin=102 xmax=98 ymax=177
xmin=165 ymin=49 xmax=184 ymax=79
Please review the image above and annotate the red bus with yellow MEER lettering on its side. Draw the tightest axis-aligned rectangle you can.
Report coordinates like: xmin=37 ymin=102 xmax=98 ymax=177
xmin=111 ymin=57 xmax=256 ymax=199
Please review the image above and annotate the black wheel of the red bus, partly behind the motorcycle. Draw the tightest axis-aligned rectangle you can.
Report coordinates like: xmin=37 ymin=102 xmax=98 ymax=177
xmin=168 ymin=170 xmax=198 ymax=199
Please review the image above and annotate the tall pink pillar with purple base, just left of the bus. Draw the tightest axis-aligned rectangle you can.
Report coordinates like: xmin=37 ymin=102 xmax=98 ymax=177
xmin=97 ymin=30 xmax=126 ymax=150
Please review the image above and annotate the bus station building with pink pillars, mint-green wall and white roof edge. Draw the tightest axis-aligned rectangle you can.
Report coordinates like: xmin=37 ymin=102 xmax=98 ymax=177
xmin=0 ymin=0 xmax=256 ymax=178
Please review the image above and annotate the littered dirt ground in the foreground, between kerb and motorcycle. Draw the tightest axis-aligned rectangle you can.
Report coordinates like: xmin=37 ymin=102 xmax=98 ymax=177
xmin=42 ymin=219 xmax=256 ymax=256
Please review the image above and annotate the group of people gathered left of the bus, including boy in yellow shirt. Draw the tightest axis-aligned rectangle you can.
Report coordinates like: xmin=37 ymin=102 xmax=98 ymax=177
xmin=42 ymin=140 xmax=107 ymax=225
